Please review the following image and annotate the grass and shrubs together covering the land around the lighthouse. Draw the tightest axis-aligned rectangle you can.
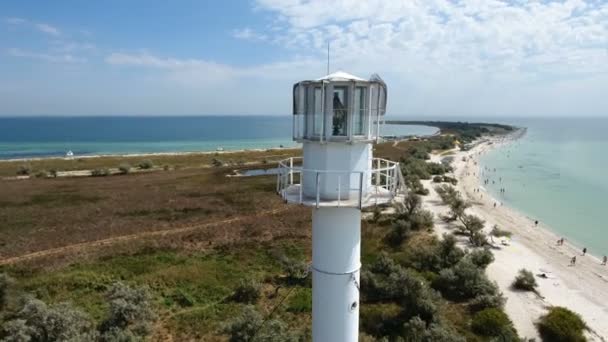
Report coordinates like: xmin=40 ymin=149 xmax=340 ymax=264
xmin=0 ymin=121 xmax=528 ymax=342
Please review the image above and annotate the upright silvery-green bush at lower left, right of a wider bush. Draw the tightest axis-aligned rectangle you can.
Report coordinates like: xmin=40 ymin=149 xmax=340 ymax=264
xmin=101 ymin=282 xmax=156 ymax=337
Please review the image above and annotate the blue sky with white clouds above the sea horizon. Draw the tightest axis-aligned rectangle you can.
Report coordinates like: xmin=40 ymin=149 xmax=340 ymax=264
xmin=0 ymin=0 xmax=608 ymax=118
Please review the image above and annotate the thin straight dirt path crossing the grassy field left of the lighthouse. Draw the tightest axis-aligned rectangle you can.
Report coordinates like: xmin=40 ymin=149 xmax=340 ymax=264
xmin=0 ymin=208 xmax=288 ymax=266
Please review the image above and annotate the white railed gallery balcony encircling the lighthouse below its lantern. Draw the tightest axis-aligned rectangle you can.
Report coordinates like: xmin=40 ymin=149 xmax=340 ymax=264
xmin=277 ymin=157 xmax=404 ymax=208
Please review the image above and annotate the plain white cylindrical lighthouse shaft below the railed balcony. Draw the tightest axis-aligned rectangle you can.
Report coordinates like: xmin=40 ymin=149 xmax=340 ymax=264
xmin=312 ymin=208 xmax=361 ymax=342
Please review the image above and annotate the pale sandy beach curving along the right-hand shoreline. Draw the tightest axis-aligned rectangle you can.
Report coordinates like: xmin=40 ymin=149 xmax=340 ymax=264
xmin=423 ymin=134 xmax=608 ymax=341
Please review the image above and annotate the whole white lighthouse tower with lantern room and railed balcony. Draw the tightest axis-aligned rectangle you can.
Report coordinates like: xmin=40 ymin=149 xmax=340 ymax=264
xmin=277 ymin=72 xmax=402 ymax=342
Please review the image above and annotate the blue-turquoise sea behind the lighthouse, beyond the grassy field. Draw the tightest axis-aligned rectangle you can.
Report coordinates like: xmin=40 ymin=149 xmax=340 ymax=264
xmin=0 ymin=115 xmax=437 ymax=159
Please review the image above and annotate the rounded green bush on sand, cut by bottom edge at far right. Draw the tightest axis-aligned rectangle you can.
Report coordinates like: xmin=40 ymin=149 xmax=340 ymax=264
xmin=537 ymin=306 xmax=587 ymax=342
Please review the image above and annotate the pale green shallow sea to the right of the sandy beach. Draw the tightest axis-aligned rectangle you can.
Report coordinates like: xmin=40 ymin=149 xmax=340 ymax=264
xmin=481 ymin=118 xmax=608 ymax=255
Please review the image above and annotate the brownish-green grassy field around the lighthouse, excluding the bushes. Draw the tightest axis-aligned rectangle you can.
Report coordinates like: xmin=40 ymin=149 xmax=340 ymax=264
xmin=0 ymin=125 xmax=516 ymax=341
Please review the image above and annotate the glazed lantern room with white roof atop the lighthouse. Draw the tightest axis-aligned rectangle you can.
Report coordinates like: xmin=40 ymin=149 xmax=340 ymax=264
xmin=293 ymin=71 xmax=387 ymax=142
